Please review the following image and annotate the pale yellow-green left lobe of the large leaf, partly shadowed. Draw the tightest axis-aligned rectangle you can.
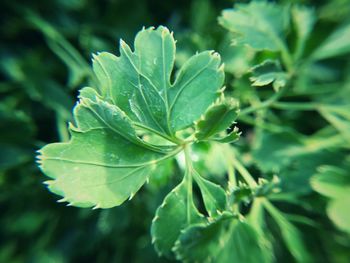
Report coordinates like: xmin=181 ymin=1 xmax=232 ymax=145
xmin=39 ymin=89 xmax=170 ymax=208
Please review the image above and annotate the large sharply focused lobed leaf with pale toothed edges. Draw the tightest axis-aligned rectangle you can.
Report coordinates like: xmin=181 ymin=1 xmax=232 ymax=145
xmin=39 ymin=26 xmax=224 ymax=208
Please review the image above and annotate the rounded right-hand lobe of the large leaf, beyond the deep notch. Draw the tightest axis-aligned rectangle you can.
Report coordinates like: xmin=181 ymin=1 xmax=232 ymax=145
xmin=169 ymin=51 xmax=224 ymax=130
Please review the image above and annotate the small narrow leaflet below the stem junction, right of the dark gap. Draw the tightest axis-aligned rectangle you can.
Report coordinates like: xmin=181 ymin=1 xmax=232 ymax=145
xmin=194 ymin=173 xmax=226 ymax=217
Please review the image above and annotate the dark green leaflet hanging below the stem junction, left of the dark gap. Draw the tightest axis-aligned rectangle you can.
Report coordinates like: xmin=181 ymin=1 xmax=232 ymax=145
xmin=151 ymin=180 xmax=203 ymax=257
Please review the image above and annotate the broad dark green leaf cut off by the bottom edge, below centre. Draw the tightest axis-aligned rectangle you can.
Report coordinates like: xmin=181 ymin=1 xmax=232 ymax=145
xmin=175 ymin=213 xmax=266 ymax=263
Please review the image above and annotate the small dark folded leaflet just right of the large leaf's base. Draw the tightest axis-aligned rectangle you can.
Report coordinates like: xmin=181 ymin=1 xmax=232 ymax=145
xmin=195 ymin=98 xmax=238 ymax=140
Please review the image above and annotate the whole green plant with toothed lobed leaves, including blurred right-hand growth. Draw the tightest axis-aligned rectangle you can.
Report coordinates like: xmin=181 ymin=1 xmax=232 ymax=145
xmin=35 ymin=2 xmax=350 ymax=262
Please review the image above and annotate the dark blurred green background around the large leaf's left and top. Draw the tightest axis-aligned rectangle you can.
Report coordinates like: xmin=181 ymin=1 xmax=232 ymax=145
xmin=0 ymin=0 xmax=350 ymax=263
